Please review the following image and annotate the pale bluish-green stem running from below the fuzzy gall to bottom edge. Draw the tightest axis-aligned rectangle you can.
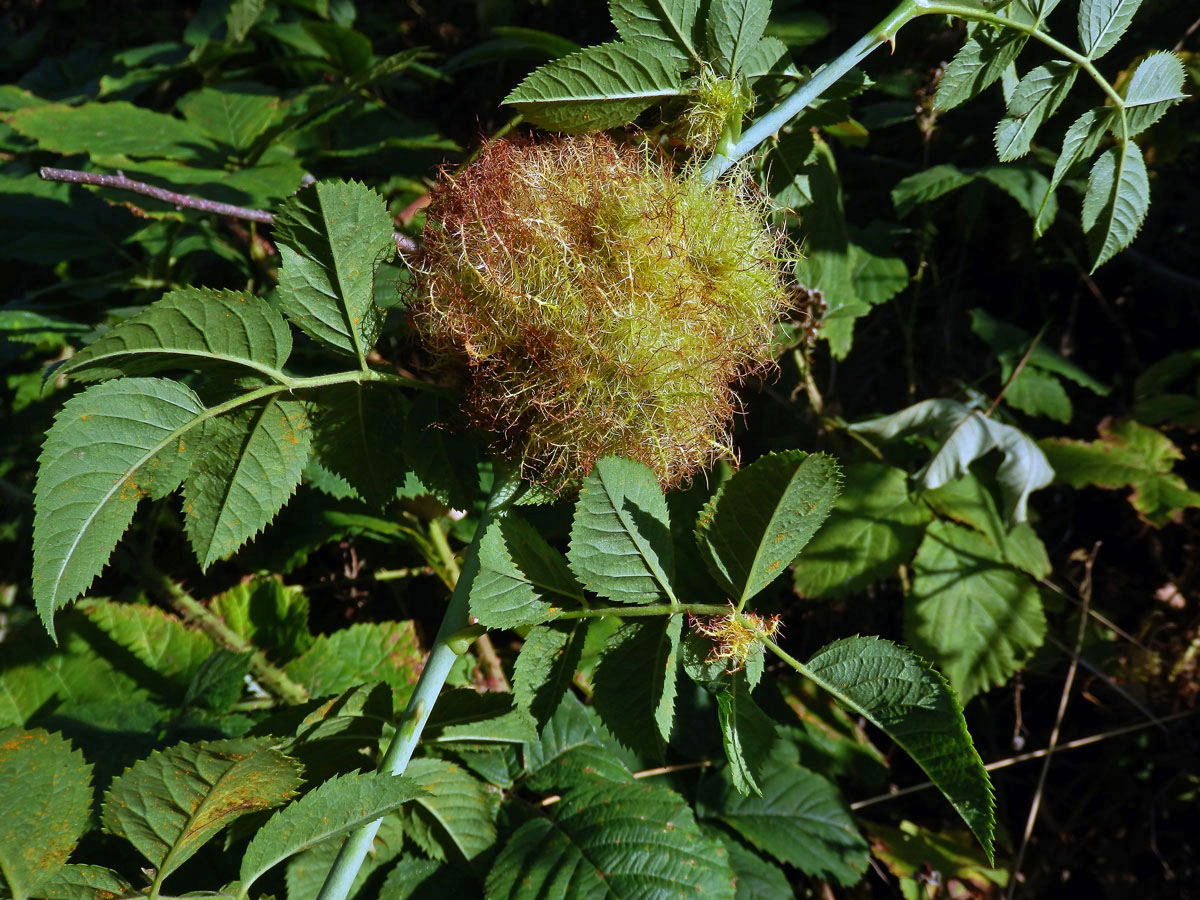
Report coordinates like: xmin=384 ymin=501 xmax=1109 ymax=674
xmin=317 ymin=469 xmax=520 ymax=900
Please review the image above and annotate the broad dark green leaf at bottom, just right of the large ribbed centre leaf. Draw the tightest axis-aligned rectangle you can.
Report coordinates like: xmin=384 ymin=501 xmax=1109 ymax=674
xmin=698 ymin=744 xmax=868 ymax=884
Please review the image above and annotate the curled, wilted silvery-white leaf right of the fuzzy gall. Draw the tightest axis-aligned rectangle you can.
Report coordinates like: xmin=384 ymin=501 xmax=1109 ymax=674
xmin=848 ymin=400 xmax=1054 ymax=524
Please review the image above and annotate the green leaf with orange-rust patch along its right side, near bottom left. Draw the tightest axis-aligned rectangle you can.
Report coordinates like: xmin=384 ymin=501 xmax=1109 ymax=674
xmin=101 ymin=738 xmax=302 ymax=882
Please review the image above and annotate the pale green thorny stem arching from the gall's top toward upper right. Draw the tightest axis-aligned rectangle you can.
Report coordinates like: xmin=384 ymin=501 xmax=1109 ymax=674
xmin=702 ymin=0 xmax=1126 ymax=181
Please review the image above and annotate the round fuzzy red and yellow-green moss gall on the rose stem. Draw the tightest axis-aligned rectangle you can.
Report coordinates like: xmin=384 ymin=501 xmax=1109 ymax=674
xmin=412 ymin=137 xmax=786 ymax=490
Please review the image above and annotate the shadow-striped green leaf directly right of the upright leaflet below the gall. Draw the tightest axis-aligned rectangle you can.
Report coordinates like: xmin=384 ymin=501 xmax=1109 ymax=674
xmin=794 ymin=462 xmax=930 ymax=598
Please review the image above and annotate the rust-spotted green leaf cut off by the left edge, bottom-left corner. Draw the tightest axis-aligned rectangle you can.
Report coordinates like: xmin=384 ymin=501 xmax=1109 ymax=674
xmin=0 ymin=727 xmax=91 ymax=896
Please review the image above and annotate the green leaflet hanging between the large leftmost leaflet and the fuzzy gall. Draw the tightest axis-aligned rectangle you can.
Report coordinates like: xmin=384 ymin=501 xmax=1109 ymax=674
xmin=184 ymin=396 xmax=312 ymax=569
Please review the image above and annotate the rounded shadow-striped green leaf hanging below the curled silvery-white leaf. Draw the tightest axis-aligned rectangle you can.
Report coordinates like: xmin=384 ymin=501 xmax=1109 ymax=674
xmin=905 ymin=522 xmax=1046 ymax=703
